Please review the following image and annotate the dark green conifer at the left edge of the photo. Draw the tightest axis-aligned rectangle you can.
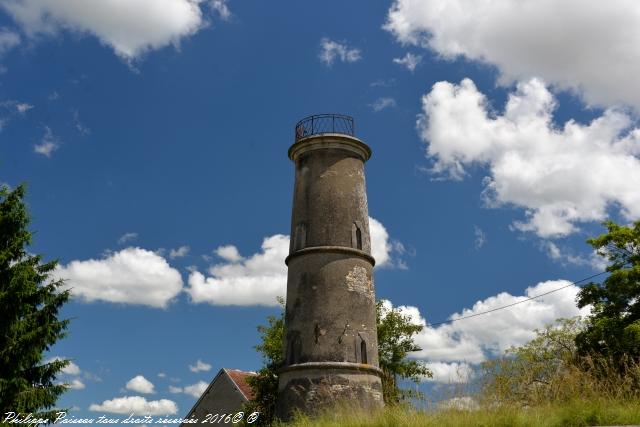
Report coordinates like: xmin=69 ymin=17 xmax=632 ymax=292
xmin=0 ymin=185 xmax=69 ymax=419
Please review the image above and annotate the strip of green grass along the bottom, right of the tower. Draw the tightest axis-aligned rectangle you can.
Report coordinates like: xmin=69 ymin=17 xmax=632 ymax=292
xmin=279 ymin=399 xmax=640 ymax=427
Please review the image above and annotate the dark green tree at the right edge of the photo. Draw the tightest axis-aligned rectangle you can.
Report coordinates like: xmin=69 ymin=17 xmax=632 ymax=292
xmin=576 ymin=221 xmax=640 ymax=368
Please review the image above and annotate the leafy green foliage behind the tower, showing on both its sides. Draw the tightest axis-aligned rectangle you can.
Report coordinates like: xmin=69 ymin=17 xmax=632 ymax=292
xmin=244 ymin=298 xmax=432 ymax=426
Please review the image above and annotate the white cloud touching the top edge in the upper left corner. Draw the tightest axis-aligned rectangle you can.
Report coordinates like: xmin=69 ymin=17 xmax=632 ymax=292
xmin=0 ymin=0 xmax=230 ymax=60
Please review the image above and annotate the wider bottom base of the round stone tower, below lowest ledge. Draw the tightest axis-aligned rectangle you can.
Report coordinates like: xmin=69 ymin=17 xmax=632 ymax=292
xmin=276 ymin=362 xmax=384 ymax=421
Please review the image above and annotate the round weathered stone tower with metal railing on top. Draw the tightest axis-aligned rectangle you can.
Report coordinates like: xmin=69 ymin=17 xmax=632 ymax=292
xmin=277 ymin=115 xmax=383 ymax=419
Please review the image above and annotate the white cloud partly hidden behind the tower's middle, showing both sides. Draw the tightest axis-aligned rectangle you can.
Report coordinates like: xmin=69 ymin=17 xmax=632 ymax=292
xmin=186 ymin=218 xmax=406 ymax=306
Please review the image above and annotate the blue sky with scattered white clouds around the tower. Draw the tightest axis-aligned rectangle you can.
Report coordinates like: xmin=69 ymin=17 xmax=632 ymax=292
xmin=0 ymin=0 xmax=640 ymax=422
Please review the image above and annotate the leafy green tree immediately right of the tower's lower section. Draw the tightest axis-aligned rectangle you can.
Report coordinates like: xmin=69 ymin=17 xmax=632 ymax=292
xmin=376 ymin=300 xmax=433 ymax=404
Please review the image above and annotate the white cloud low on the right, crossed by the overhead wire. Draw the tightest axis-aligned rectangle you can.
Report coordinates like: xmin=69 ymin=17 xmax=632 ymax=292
xmin=385 ymin=280 xmax=589 ymax=383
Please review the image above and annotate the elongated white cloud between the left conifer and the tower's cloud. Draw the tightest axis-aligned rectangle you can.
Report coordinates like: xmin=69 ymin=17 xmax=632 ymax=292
xmin=55 ymin=247 xmax=182 ymax=307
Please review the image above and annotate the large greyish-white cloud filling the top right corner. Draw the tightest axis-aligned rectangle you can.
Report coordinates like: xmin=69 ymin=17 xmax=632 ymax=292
xmin=385 ymin=0 xmax=640 ymax=107
